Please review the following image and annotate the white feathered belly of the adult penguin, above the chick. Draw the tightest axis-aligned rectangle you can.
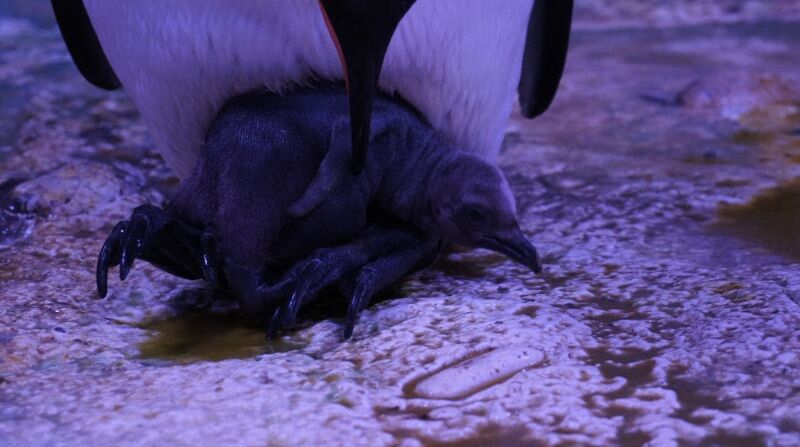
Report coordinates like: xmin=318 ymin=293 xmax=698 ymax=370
xmin=84 ymin=0 xmax=533 ymax=177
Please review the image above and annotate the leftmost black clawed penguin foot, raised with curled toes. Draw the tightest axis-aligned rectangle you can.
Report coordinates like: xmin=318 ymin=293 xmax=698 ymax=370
xmin=96 ymin=205 xmax=219 ymax=298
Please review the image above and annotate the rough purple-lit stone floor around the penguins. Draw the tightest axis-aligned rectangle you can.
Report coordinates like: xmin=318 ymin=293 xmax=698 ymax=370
xmin=0 ymin=2 xmax=800 ymax=446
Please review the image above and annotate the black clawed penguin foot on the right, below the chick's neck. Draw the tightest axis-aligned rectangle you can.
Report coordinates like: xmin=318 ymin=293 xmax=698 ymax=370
xmin=267 ymin=226 xmax=438 ymax=339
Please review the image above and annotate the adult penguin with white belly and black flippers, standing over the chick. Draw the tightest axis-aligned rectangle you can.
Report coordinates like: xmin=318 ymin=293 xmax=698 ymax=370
xmin=52 ymin=0 xmax=572 ymax=177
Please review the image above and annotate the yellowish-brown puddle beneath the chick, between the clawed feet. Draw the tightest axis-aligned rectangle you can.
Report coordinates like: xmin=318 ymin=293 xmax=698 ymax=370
xmin=138 ymin=312 xmax=305 ymax=363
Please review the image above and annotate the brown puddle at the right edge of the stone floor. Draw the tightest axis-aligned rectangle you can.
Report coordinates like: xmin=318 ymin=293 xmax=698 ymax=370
xmin=713 ymin=180 xmax=800 ymax=260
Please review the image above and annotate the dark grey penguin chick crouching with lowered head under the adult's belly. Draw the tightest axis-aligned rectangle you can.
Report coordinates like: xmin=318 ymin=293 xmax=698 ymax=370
xmin=97 ymin=87 xmax=541 ymax=337
